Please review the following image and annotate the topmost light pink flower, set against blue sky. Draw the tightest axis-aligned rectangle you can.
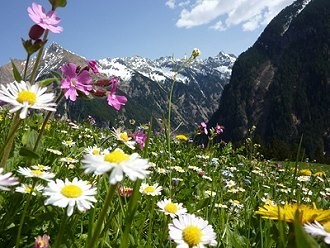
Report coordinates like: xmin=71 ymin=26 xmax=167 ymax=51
xmin=27 ymin=3 xmax=63 ymax=33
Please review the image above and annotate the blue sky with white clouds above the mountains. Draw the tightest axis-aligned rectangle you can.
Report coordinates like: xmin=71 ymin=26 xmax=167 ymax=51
xmin=0 ymin=0 xmax=293 ymax=65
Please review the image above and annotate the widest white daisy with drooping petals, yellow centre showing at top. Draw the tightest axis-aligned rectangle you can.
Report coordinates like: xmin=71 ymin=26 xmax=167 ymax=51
xmin=82 ymin=148 xmax=150 ymax=184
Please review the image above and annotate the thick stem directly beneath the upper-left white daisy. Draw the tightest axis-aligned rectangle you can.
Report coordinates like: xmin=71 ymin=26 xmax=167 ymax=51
xmin=0 ymin=113 xmax=22 ymax=169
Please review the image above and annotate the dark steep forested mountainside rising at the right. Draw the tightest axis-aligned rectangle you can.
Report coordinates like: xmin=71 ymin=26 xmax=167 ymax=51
xmin=209 ymin=0 xmax=330 ymax=163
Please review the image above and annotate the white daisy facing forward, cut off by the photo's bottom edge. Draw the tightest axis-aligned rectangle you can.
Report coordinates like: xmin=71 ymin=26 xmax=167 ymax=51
xmin=168 ymin=214 xmax=217 ymax=248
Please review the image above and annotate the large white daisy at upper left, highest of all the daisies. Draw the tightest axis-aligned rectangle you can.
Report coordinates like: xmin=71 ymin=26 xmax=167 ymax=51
xmin=0 ymin=81 xmax=56 ymax=119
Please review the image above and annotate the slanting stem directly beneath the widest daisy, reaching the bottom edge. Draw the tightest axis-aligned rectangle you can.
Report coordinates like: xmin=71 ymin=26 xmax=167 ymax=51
xmin=86 ymin=181 xmax=117 ymax=248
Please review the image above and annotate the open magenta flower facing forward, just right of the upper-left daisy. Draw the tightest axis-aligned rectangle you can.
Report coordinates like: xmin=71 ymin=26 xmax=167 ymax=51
xmin=61 ymin=63 xmax=93 ymax=101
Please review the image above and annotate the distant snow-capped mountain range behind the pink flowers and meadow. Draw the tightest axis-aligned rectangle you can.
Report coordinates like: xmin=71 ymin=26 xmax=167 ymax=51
xmin=0 ymin=43 xmax=236 ymax=132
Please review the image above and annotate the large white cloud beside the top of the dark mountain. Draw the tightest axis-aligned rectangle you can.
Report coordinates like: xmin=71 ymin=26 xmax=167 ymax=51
xmin=174 ymin=0 xmax=294 ymax=31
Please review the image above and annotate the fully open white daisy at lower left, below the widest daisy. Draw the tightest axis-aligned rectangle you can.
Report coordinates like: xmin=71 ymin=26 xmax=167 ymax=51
xmin=44 ymin=178 xmax=97 ymax=216
